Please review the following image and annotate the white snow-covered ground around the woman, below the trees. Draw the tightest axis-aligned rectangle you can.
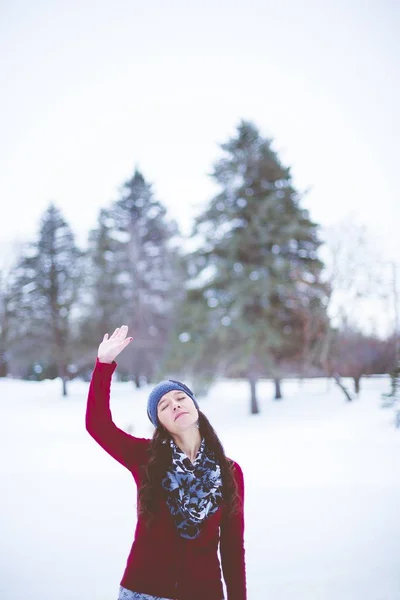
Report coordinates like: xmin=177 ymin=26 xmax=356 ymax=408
xmin=0 ymin=370 xmax=400 ymax=600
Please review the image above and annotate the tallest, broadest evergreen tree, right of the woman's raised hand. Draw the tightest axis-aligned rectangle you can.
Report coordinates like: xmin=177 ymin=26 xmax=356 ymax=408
xmin=178 ymin=122 xmax=325 ymax=413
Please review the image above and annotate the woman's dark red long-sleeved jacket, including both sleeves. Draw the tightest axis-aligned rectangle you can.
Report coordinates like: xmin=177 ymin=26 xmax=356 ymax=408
xmin=86 ymin=359 xmax=246 ymax=600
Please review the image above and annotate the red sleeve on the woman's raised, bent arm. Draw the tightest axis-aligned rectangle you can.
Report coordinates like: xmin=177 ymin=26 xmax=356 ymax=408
xmin=86 ymin=358 xmax=150 ymax=480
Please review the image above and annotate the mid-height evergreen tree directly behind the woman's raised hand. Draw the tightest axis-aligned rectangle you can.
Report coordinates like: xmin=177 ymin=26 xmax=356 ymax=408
xmin=102 ymin=169 xmax=184 ymax=386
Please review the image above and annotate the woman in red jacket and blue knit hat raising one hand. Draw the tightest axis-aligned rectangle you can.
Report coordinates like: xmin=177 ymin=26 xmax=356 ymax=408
xmin=86 ymin=325 xmax=246 ymax=600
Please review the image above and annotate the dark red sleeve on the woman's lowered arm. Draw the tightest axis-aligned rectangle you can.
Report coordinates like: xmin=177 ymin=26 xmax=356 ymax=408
xmin=220 ymin=463 xmax=247 ymax=600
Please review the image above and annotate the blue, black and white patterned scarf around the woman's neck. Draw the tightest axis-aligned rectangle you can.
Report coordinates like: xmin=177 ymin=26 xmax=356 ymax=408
xmin=162 ymin=438 xmax=222 ymax=539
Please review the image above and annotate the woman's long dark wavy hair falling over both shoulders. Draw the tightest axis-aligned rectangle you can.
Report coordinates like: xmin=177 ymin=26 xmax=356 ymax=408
xmin=139 ymin=410 xmax=240 ymax=526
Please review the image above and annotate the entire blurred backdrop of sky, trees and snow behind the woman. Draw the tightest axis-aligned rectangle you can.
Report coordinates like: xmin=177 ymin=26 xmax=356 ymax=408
xmin=0 ymin=0 xmax=400 ymax=600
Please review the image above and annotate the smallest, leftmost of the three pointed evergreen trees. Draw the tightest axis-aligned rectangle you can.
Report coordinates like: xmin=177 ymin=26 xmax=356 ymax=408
xmin=10 ymin=204 xmax=81 ymax=396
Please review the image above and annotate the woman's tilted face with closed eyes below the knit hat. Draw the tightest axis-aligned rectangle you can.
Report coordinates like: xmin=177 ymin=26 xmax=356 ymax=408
xmin=157 ymin=390 xmax=199 ymax=433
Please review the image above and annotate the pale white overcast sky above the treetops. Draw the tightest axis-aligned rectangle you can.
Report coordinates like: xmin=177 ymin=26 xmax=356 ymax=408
xmin=0 ymin=0 xmax=400 ymax=270
